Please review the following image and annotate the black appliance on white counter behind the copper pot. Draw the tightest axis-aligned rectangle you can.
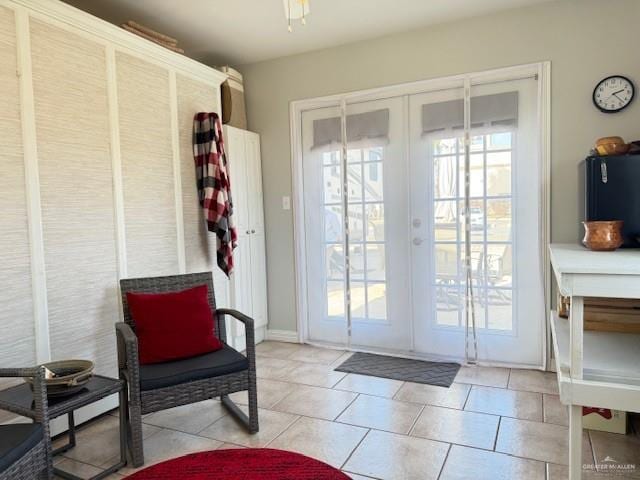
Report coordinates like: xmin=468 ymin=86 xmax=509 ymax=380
xmin=585 ymin=155 xmax=640 ymax=248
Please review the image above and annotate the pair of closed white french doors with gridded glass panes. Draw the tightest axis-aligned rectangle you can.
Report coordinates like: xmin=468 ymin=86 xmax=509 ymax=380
xmin=297 ymin=62 xmax=545 ymax=366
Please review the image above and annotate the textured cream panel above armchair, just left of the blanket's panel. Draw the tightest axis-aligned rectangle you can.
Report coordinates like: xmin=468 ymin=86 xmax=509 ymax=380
xmin=116 ymin=53 xmax=178 ymax=277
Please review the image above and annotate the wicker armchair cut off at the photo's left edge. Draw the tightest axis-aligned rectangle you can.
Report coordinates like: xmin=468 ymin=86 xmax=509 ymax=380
xmin=0 ymin=367 xmax=53 ymax=480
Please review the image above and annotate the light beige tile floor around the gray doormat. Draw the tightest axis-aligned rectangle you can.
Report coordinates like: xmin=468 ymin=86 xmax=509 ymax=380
xmin=51 ymin=342 xmax=640 ymax=480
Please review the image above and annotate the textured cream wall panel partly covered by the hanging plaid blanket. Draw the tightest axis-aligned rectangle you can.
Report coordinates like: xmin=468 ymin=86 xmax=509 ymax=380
xmin=176 ymin=75 xmax=229 ymax=305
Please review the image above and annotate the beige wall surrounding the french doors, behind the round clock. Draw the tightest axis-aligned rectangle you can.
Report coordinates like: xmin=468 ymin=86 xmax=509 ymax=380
xmin=242 ymin=0 xmax=640 ymax=330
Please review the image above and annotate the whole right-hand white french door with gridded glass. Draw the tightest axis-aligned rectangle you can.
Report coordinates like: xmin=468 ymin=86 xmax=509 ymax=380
xmin=410 ymin=78 xmax=544 ymax=365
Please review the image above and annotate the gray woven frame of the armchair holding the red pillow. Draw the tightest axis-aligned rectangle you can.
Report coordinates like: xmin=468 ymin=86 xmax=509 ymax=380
xmin=117 ymin=272 xmax=259 ymax=466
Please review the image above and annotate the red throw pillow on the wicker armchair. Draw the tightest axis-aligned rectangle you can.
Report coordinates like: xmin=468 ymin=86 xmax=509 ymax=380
xmin=127 ymin=285 xmax=222 ymax=365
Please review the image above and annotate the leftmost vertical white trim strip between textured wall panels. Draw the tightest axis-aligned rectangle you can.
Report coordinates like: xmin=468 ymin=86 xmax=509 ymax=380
xmin=14 ymin=8 xmax=51 ymax=363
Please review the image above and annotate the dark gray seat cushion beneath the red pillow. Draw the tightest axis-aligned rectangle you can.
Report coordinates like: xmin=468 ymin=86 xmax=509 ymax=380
xmin=140 ymin=345 xmax=249 ymax=390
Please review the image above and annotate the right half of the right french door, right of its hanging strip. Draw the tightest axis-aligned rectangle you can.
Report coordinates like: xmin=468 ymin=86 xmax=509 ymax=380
xmin=471 ymin=77 xmax=545 ymax=366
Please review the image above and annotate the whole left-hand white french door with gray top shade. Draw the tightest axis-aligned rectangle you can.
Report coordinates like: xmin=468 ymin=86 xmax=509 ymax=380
xmin=302 ymin=98 xmax=411 ymax=350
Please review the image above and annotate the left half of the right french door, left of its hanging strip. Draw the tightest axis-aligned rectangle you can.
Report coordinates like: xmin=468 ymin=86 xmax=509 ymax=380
xmin=407 ymin=82 xmax=465 ymax=358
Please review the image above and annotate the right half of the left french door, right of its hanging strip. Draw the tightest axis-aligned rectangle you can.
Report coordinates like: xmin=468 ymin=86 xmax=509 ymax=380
xmin=346 ymin=97 xmax=411 ymax=350
